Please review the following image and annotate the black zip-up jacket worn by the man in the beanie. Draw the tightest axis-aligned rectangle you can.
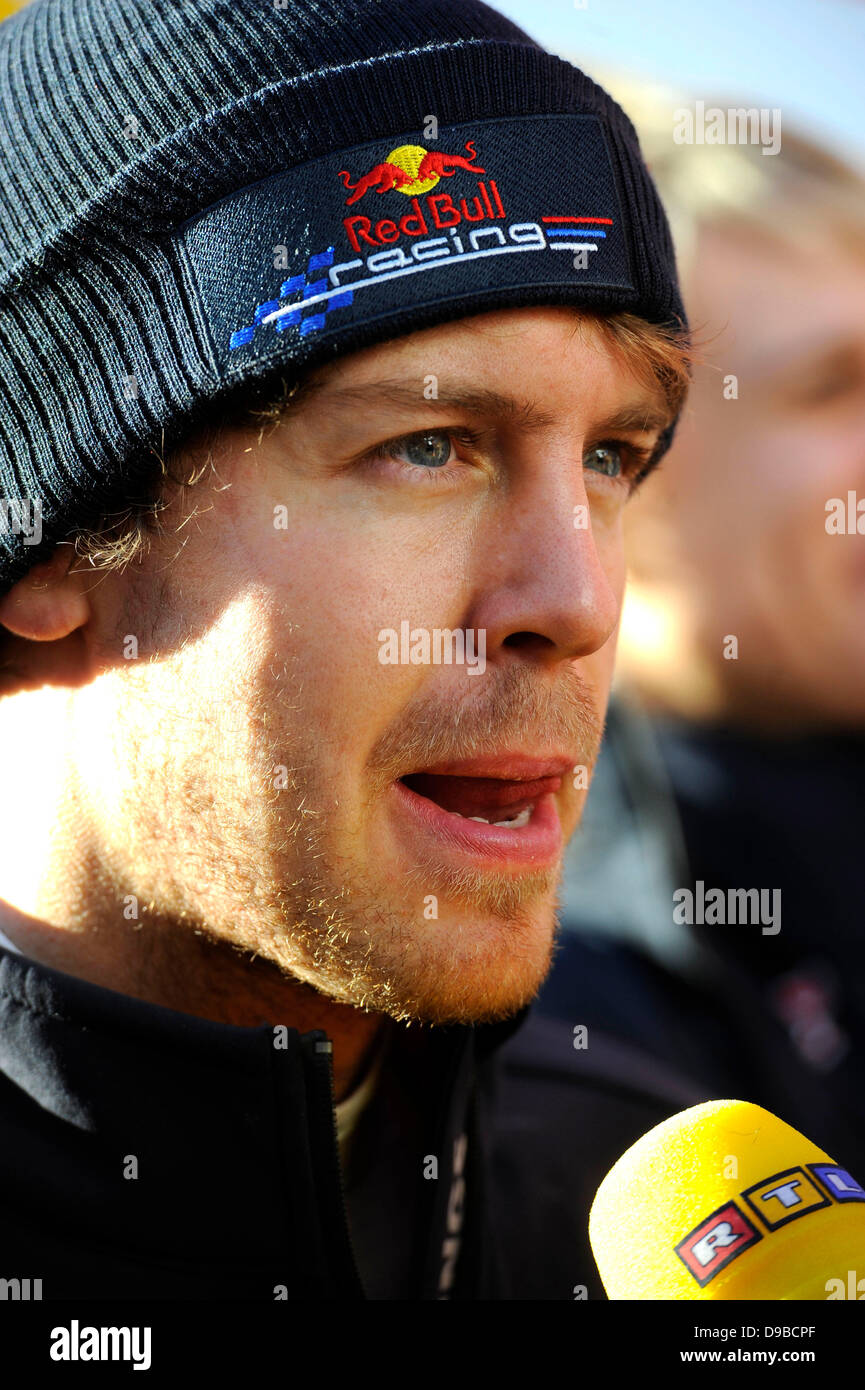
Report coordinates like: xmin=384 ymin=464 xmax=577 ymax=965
xmin=0 ymin=951 xmax=701 ymax=1301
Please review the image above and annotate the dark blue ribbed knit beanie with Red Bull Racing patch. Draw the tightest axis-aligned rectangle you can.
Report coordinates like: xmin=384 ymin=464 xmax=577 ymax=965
xmin=0 ymin=0 xmax=686 ymax=594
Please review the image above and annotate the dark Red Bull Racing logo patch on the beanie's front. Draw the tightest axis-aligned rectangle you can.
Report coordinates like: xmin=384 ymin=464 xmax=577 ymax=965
xmin=218 ymin=115 xmax=634 ymax=353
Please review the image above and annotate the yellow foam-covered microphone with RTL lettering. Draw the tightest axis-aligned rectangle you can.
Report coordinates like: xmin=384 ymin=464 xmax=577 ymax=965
xmin=588 ymin=1101 xmax=865 ymax=1300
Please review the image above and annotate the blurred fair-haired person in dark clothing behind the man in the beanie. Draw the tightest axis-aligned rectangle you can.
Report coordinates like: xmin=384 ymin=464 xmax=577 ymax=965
xmin=541 ymin=100 xmax=865 ymax=1172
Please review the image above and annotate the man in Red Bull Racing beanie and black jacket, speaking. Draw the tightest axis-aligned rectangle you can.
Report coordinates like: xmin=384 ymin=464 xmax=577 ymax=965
xmin=0 ymin=0 xmax=690 ymax=1298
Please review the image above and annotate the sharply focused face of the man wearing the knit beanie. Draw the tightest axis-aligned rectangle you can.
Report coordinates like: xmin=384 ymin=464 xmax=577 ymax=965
xmin=75 ymin=309 xmax=667 ymax=1023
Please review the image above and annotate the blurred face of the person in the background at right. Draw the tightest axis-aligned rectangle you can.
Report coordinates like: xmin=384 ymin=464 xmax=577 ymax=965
xmin=653 ymin=232 xmax=865 ymax=726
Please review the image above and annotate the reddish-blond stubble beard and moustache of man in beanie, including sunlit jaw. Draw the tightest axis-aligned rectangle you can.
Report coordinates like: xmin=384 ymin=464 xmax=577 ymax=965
xmin=113 ymin=628 xmax=601 ymax=1024
